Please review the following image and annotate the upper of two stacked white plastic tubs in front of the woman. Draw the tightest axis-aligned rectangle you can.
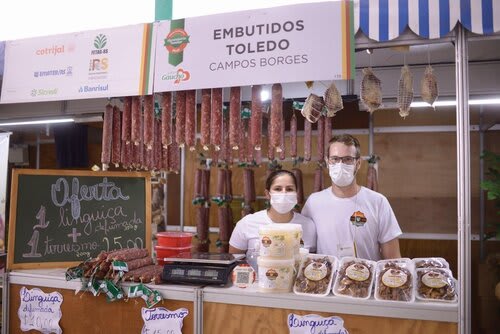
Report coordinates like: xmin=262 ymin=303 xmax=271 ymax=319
xmin=259 ymin=224 xmax=302 ymax=259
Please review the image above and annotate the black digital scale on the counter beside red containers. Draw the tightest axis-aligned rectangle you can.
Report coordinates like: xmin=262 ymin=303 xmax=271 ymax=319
xmin=162 ymin=253 xmax=245 ymax=285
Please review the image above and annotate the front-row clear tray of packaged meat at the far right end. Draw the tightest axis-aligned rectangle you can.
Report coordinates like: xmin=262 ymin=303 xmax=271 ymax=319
xmin=416 ymin=268 xmax=457 ymax=303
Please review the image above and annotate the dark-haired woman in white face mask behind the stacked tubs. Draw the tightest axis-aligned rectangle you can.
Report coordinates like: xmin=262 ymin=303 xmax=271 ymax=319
xmin=229 ymin=169 xmax=316 ymax=254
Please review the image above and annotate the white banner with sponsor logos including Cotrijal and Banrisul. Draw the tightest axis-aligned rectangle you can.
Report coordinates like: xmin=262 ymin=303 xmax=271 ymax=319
xmin=0 ymin=24 xmax=153 ymax=103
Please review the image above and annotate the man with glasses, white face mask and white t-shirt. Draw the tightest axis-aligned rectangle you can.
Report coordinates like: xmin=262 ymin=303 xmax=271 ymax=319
xmin=302 ymin=134 xmax=402 ymax=261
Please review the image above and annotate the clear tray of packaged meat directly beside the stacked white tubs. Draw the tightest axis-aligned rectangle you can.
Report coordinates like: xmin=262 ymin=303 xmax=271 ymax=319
xmin=293 ymin=254 xmax=337 ymax=296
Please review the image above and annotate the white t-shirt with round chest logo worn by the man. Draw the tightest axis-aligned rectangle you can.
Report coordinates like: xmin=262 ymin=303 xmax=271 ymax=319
xmin=302 ymin=187 xmax=402 ymax=261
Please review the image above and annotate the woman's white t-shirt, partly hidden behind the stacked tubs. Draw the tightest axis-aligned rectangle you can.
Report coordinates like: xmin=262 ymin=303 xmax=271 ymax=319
xmin=229 ymin=210 xmax=316 ymax=250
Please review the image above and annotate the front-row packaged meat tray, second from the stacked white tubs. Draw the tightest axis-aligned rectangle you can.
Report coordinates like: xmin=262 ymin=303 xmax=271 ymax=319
xmin=333 ymin=256 xmax=377 ymax=299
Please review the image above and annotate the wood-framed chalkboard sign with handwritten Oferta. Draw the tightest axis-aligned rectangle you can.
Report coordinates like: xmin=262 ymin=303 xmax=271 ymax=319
xmin=7 ymin=169 xmax=151 ymax=269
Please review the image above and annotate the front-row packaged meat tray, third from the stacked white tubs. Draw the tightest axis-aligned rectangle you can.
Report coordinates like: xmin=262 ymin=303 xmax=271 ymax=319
xmin=375 ymin=258 xmax=415 ymax=302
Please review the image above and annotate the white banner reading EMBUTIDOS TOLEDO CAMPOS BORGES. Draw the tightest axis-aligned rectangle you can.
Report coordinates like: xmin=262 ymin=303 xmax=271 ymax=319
xmin=154 ymin=1 xmax=354 ymax=92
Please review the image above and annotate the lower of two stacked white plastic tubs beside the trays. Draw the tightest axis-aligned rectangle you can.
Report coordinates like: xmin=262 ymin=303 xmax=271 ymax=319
xmin=257 ymin=256 xmax=295 ymax=292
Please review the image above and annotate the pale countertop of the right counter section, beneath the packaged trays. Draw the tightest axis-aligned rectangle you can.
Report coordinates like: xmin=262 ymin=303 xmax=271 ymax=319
xmin=203 ymin=284 xmax=458 ymax=323
